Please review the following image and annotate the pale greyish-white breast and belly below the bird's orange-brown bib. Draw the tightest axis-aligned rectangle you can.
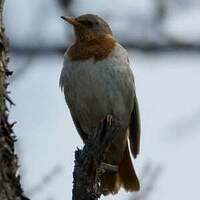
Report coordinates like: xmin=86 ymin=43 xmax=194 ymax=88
xmin=60 ymin=44 xmax=134 ymax=135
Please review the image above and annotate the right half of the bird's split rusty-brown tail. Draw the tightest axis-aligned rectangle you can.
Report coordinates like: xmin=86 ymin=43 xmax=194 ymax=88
xmin=119 ymin=145 xmax=140 ymax=192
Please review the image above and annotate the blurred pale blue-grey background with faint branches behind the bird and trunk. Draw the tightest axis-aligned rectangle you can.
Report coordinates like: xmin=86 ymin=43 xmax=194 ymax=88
xmin=4 ymin=0 xmax=200 ymax=200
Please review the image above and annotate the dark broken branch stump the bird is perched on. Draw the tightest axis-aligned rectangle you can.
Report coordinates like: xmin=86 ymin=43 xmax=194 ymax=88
xmin=72 ymin=119 xmax=122 ymax=200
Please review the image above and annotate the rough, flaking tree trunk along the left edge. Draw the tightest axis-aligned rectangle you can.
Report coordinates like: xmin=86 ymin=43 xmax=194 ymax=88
xmin=0 ymin=0 xmax=27 ymax=200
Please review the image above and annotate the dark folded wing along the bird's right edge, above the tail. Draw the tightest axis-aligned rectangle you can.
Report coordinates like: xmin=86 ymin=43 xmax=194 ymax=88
xmin=129 ymin=96 xmax=141 ymax=158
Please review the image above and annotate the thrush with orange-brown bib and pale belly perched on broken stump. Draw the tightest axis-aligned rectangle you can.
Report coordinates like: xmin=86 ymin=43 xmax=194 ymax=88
xmin=59 ymin=14 xmax=141 ymax=195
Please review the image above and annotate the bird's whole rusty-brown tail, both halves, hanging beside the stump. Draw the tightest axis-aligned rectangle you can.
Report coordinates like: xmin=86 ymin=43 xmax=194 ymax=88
xmin=101 ymin=145 xmax=140 ymax=195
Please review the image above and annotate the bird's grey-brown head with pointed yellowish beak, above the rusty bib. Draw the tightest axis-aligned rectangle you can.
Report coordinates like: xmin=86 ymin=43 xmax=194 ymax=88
xmin=61 ymin=14 xmax=112 ymax=41
